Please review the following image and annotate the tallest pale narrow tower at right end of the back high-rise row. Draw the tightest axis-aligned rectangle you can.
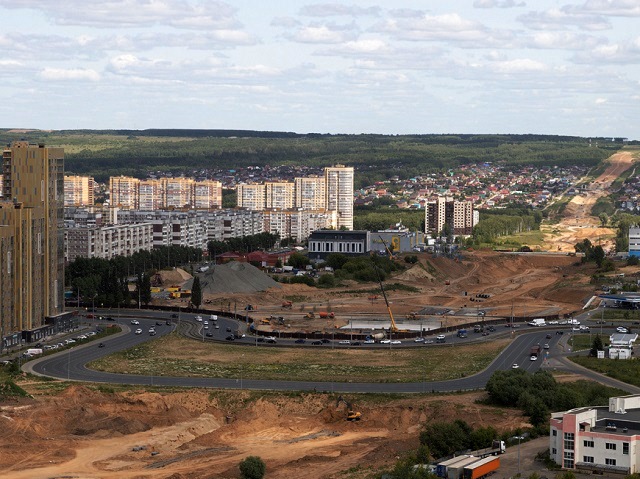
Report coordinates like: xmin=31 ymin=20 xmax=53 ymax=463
xmin=324 ymin=165 xmax=353 ymax=230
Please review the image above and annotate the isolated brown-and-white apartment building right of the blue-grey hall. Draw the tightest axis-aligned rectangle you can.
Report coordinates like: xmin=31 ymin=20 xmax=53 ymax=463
xmin=424 ymin=196 xmax=474 ymax=236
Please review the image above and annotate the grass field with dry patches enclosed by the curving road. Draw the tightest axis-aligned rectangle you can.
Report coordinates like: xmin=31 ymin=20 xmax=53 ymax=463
xmin=89 ymin=334 xmax=509 ymax=383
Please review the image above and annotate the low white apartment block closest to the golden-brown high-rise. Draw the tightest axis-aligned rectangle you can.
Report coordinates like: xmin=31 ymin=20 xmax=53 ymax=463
xmin=65 ymin=223 xmax=153 ymax=262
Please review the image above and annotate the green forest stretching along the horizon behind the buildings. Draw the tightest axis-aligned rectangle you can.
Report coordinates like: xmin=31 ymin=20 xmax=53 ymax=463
xmin=0 ymin=129 xmax=621 ymax=188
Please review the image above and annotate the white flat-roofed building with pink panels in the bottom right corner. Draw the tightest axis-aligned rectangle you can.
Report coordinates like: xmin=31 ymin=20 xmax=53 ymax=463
xmin=549 ymin=395 xmax=640 ymax=475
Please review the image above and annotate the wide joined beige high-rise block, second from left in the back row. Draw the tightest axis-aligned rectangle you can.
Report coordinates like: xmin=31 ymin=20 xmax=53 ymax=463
xmin=109 ymin=176 xmax=222 ymax=210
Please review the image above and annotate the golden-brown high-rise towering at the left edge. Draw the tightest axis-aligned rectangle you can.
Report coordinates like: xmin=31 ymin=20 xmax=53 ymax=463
xmin=0 ymin=141 xmax=64 ymax=346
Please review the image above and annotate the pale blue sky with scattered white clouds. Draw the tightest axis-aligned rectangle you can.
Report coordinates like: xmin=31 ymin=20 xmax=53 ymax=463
xmin=0 ymin=0 xmax=640 ymax=139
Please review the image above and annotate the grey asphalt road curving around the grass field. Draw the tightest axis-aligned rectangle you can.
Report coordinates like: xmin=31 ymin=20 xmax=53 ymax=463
xmin=23 ymin=311 xmax=628 ymax=393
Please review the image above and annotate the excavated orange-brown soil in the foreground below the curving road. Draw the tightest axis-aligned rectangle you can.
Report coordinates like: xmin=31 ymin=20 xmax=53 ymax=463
xmin=0 ymin=385 xmax=526 ymax=479
